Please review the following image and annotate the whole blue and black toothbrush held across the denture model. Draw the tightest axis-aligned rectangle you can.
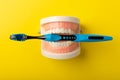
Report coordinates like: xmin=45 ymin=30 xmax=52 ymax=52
xmin=10 ymin=34 xmax=113 ymax=42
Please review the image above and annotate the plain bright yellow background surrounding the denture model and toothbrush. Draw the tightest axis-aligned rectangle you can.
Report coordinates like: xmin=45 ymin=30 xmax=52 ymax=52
xmin=0 ymin=0 xmax=120 ymax=80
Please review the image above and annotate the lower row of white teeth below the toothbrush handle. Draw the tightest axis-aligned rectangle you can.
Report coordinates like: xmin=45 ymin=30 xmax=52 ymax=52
xmin=49 ymin=41 xmax=73 ymax=47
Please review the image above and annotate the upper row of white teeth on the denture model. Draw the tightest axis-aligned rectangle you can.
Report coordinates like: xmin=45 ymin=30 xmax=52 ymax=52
xmin=41 ymin=28 xmax=75 ymax=34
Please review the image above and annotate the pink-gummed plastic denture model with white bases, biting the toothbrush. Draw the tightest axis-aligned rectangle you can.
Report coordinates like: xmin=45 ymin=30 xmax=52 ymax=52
xmin=40 ymin=16 xmax=80 ymax=59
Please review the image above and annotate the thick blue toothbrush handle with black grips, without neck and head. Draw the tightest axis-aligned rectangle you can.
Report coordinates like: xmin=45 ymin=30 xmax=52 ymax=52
xmin=44 ymin=34 xmax=112 ymax=42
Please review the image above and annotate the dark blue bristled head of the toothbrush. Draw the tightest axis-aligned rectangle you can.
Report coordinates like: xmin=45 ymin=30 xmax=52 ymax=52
xmin=10 ymin=34 xmax=27 ymax=41
